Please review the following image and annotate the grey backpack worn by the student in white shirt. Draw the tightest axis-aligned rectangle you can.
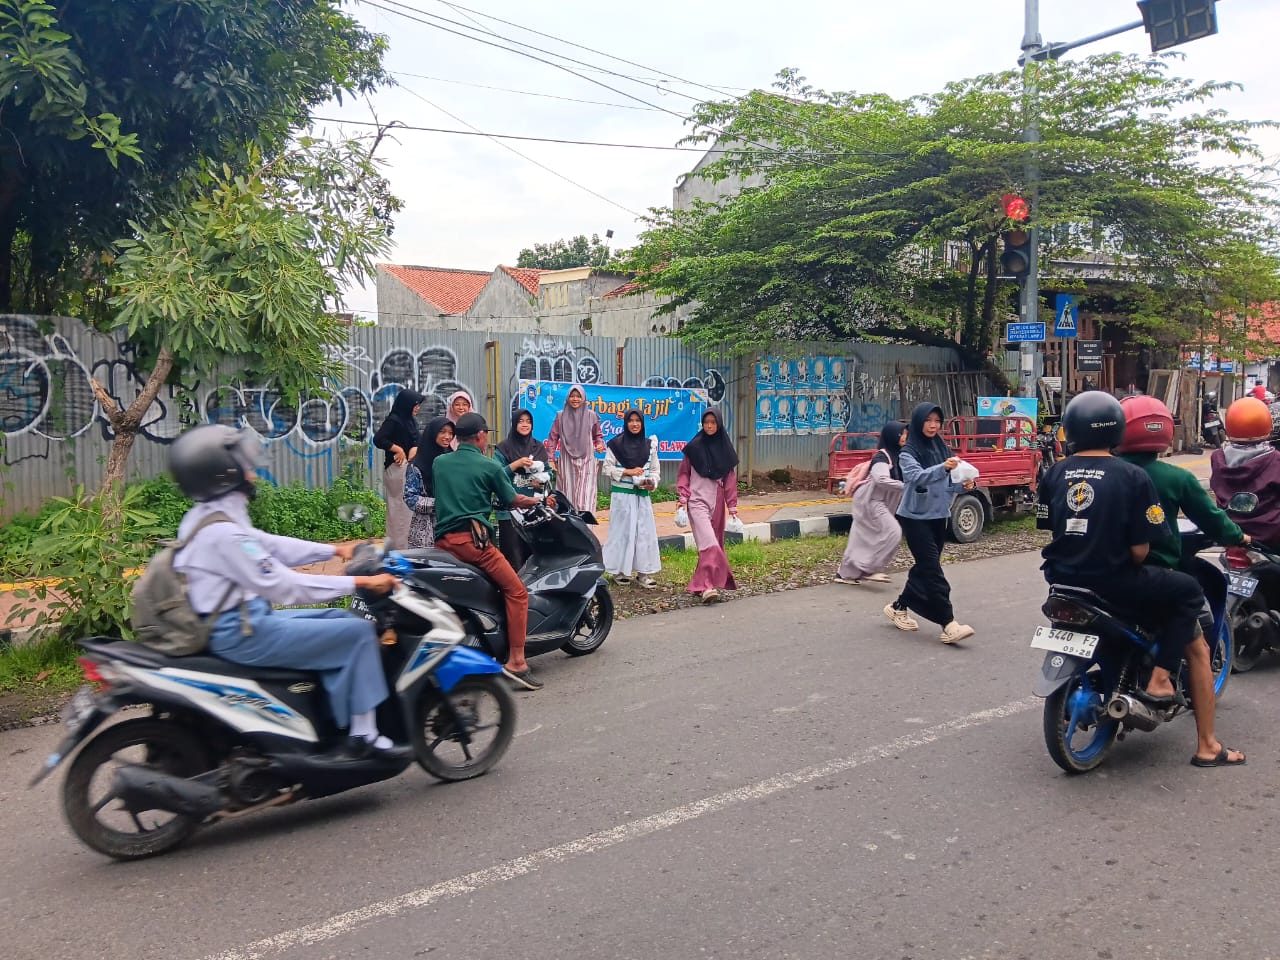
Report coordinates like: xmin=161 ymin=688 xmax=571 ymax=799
xmin=129 ymin=513 xmax=236 ymax=657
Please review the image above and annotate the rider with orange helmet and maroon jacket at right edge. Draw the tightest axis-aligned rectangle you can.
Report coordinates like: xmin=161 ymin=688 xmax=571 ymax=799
xmin=1208 ymin=397 xmax=1280 ymax=547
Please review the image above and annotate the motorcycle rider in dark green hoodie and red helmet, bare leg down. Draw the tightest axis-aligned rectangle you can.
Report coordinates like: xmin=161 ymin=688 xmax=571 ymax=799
xmin=1116 ymin=397 xmax=1249 ymax=767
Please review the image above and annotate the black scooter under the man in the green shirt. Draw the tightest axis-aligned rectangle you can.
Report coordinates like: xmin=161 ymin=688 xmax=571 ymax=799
xmin=348 ymin=494 xmax=613 ymax=663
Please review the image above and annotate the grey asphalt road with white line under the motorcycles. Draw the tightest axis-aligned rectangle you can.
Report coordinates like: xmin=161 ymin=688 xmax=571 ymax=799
xmin=0 ymin=554 xmax=1280 ymax=960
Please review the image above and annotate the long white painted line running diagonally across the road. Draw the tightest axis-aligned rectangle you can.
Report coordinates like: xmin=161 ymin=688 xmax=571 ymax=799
xmin=205 ymin=696 xmax=1043 ymax=960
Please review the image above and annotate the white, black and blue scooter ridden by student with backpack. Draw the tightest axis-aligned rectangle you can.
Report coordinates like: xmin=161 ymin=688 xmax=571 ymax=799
xmin=31 ymin=545 xmax=516 ymax=860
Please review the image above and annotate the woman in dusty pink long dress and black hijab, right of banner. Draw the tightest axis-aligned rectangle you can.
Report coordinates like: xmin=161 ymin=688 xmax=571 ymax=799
xmin=676 ymin=407 xmax=737 ymax=603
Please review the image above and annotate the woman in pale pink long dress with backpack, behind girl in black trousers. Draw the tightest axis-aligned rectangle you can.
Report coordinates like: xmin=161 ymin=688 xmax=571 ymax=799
xmin=836 ymin=420 xmax=906 ymax=584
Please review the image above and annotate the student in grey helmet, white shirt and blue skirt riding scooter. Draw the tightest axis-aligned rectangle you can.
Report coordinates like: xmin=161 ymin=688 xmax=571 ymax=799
xmin=169 ymin=424 xmax=411 ymax=760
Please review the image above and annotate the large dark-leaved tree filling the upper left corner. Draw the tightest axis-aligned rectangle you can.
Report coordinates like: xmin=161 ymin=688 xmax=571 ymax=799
xmin=0 ymin=0 xmax=387 ymax=313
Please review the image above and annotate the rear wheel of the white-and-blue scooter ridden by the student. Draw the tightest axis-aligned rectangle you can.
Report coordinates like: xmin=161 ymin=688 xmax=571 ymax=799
xmin=63 ymin=717 xmax=209 ymax=860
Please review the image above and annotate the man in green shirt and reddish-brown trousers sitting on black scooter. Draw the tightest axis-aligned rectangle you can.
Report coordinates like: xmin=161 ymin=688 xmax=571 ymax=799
xmin=431 ymin=413 xmax=544 ymax=690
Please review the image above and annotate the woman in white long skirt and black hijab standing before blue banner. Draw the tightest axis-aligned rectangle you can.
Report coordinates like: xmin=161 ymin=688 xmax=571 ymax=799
xmin=604 ymin=410 xmax=662 ymax=590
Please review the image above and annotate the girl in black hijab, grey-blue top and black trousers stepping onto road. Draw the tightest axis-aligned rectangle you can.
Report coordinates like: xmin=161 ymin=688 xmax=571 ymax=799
xmin=884 ymin=403 xmax=974 ymax=644
